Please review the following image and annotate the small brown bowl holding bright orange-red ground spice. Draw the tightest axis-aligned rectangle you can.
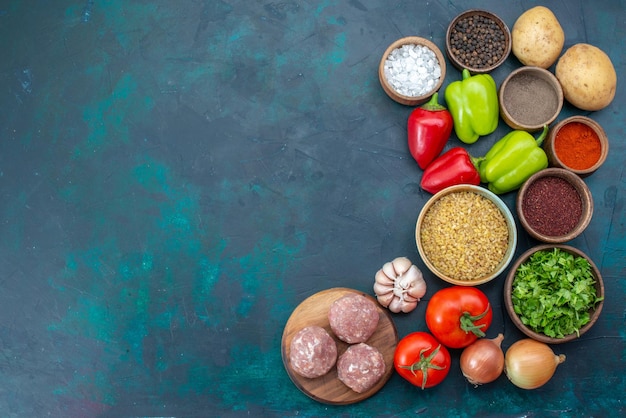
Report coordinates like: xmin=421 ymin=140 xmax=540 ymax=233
xmin=543 ymin=116 xmax=609 ymax=177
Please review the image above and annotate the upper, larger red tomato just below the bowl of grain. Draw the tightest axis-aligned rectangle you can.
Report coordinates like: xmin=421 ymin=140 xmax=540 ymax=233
xmin=426 ymin=286 xmax=493 ymax=348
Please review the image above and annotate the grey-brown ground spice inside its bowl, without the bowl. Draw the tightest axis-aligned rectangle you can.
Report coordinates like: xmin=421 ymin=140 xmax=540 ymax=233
xmin=502 ymin=74 xmax=559 ymax=126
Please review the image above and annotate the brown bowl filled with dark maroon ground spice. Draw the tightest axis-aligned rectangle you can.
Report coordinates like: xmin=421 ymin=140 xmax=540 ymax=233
xmin=516 ymin=167 xmax=593 ymax=244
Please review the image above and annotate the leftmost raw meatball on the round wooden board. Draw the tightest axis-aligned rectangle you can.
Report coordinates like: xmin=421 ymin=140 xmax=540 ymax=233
xmin=289 ymin=325 xmax=337 ymax=378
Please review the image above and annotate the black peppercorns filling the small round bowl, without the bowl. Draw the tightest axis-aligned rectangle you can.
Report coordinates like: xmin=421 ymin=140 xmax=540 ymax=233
xmin=450 ymin=15 xmax=506 ymax=68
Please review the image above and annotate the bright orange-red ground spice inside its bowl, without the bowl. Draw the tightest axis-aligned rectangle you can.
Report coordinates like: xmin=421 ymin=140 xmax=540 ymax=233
xmin=554 ymin=122 xmax=602 ymax=170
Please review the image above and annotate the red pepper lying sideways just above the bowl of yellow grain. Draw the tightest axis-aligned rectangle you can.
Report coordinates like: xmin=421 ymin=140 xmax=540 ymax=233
xmin=420 ymin=147 xmax=480 ymax=194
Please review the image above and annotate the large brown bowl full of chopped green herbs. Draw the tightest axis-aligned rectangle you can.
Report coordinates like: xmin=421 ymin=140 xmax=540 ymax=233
xmin=504 ymin=244 xmax=604 ymax=344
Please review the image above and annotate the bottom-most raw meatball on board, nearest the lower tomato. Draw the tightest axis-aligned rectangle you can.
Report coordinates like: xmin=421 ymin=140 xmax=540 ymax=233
xmin=337 ymin=343 xmax=385 ymax=393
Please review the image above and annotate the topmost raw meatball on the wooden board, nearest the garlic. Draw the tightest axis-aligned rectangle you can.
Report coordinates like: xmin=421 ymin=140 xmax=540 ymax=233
xmin=328 ymin=294 xmax=378 ymax=344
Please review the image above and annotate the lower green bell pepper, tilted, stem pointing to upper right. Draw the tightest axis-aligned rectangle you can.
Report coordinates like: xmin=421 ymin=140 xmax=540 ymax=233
xmin=477 ymin=125 xmax=548 ymax=194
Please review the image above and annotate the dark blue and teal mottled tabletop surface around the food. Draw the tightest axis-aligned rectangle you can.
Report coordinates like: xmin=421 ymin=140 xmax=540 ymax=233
xmin=0 ymin=0 xmax=626 ymax=417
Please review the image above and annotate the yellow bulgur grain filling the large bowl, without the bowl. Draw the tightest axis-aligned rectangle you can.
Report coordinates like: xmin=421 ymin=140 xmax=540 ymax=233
xmin=420 ymin=192 xmax=509 ymax=280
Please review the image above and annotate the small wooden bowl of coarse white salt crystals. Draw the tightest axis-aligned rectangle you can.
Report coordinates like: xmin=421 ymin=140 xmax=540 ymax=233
xmin=378 ymin=36 xmax=446 ymax=106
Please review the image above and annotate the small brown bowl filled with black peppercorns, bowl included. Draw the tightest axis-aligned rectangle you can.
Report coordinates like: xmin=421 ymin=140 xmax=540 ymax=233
xmin=446 ymin=9 xmax=511 ymax=74
